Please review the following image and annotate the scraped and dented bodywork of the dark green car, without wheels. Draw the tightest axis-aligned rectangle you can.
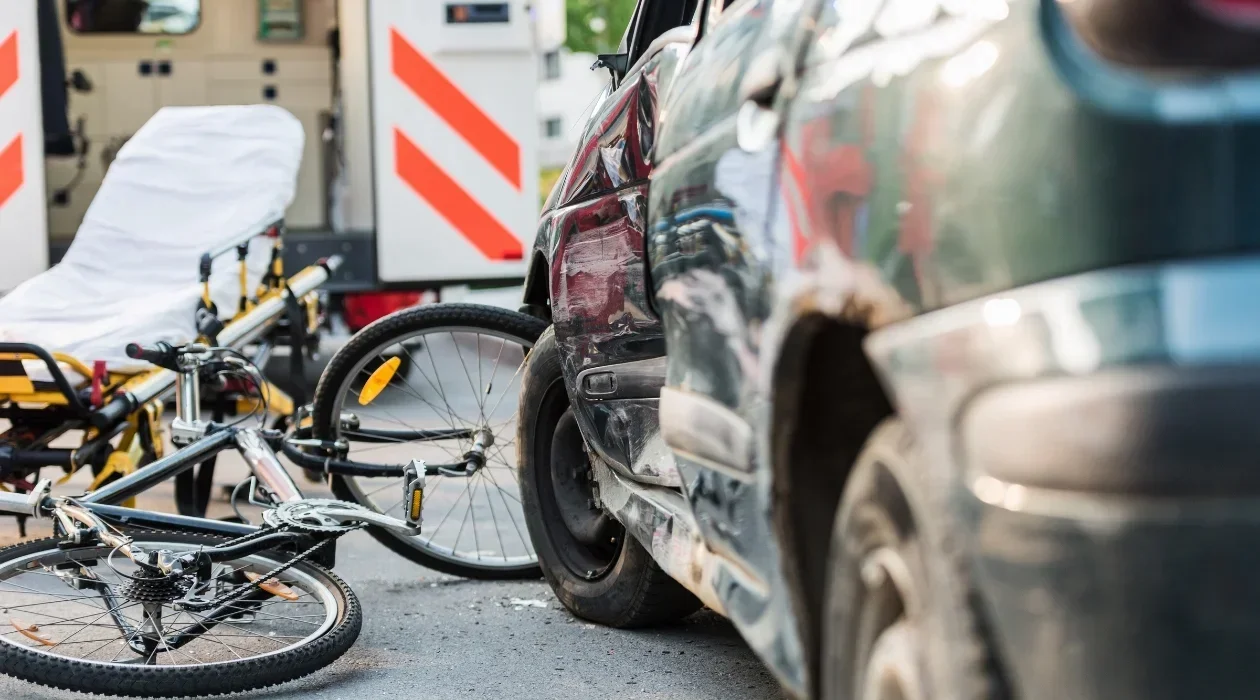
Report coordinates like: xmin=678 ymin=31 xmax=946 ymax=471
xmin=538 ymin=0 xmax=1260 ymax=697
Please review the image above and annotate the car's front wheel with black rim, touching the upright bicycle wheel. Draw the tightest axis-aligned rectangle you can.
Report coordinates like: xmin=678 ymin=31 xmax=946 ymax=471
xmin=517 ymin=329 xmax=701 ymax=627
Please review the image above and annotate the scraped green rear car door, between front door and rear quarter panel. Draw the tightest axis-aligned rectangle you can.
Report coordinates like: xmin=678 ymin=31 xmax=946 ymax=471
xmin=648 ymin=0 xmax=806 ymax=596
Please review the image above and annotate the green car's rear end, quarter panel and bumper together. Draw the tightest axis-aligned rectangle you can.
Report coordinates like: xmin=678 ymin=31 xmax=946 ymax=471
xmin=762 ymin=0 xmax=1260 ymax=699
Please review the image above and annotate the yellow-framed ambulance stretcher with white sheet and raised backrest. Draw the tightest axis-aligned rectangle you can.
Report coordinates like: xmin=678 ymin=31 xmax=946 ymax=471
xmin=0 ymin=106 xmax=339 ymax=518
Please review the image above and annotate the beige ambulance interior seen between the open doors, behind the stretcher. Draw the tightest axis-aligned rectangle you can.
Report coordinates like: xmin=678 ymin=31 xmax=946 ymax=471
xmin=42 ymin=0 xmax=341 ymax=251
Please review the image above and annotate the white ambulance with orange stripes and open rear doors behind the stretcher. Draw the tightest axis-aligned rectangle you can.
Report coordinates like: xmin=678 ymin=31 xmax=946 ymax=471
xmin=0 ymin=0 xmax=564 ymax=305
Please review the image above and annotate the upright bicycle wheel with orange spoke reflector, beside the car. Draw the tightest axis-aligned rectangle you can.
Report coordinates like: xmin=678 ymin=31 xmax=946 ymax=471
xmin=311 ymin=303 xmax=547 ymax=579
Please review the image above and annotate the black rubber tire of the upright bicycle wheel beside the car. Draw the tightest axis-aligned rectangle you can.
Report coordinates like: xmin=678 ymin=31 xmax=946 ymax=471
xmin=311 ymin=303 xmax=547 ymax=580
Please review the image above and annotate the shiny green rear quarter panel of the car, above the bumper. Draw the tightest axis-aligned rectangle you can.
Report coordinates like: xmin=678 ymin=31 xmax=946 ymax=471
xmin=785 ymin=1 xmax=1260 ymax=312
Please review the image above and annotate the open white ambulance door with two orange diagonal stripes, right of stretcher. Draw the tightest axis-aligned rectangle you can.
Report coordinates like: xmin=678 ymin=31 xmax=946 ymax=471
xmin=367 ymin=0 xmax=539 ymax=285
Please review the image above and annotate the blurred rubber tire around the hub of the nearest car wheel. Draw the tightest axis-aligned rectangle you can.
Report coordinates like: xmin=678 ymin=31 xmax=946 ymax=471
xmin=822 ymin=418 xmax=1008 ymax=700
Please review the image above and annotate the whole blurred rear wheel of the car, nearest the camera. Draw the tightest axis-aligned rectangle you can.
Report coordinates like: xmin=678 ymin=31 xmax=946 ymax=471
xmin=822 ymin=418 xmax=1009 ymax=700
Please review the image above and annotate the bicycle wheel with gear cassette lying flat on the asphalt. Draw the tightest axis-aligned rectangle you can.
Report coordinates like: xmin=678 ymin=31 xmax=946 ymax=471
xmin=0 ymin=533 xmax=363 ymax=697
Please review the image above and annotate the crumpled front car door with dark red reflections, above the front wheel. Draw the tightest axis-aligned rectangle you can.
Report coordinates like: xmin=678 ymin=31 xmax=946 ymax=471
xmin=525 ymin=0 xmax=696 ymax=486
